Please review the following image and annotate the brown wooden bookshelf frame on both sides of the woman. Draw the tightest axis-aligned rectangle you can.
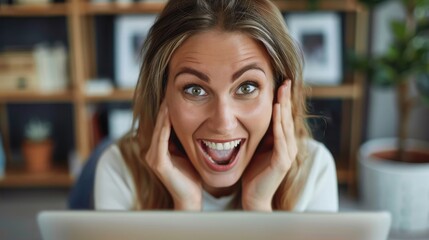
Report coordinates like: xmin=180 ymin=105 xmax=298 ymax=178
xmin=0 ymin=0 xmax=369 ymax=188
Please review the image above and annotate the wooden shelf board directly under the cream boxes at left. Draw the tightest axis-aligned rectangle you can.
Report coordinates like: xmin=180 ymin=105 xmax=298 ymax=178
xmin=0 ymin=91 xmax=73 ymax=103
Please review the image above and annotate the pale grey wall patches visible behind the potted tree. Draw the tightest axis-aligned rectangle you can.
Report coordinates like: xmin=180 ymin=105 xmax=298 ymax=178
xmin=367 ymin=1 xmax=429 ymax=141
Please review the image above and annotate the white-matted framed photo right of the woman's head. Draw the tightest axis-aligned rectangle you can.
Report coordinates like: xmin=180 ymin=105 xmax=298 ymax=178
xmin=285 ymin=12 xmax=342 ymax=85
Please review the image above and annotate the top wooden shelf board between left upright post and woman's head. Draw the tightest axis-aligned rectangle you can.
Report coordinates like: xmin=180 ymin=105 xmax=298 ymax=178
xmin=79 ymin=3 xmax=165 ymax=15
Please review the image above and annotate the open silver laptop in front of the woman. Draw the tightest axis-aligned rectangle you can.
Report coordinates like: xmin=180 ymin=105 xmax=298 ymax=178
xmin=37 ymin=211 xmax=391 ymax=240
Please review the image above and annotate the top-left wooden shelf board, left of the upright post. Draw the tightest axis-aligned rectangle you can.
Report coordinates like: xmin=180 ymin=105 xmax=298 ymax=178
xmin=0 ymin=3 xmax=68 ymax=17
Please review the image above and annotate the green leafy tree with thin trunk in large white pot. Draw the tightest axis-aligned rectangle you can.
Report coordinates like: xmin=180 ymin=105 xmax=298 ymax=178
xmin=350 ymin=0 xmax=429 ymax=161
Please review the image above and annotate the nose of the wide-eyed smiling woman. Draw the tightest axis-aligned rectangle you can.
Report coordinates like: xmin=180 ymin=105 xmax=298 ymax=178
xmin=208 ymin=98 xmax=238 ymax=135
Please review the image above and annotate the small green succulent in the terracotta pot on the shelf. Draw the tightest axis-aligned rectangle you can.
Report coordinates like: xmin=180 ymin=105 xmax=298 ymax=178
xmin=24 ymin=119 xmax=52 ymax=142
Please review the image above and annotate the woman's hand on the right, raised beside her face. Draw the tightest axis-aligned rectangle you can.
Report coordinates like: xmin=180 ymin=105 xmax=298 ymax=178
xmin=242 ymin=80 xmax=298 ymax=211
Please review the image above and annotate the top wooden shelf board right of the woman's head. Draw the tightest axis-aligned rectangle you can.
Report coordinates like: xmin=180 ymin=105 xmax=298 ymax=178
xmin=273 ymin=0 xmax=363 ymax=12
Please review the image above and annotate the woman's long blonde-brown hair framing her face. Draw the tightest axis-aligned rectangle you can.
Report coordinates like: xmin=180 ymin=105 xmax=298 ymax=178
xmin=118 ymin=0 xmax=309 ymax=210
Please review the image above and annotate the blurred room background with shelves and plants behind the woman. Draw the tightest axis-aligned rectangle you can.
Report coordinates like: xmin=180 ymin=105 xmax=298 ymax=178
xmin=0 ymin=0 xmax=429 ymax=240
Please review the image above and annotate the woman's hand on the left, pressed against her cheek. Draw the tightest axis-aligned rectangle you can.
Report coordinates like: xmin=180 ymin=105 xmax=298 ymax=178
xmin=146 ymin=101 xmax=202 ymax=210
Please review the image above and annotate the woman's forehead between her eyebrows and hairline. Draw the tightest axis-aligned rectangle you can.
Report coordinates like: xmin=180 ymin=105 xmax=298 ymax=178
xmin=170 ymin=29 xmax=271 ymax=68
